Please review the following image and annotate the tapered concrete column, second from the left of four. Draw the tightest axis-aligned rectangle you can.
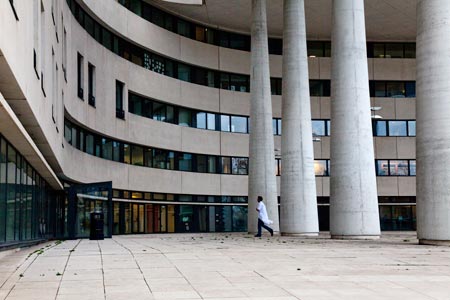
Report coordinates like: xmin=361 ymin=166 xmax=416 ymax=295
xmin=280 ymin=0 xmax=319 ymax=235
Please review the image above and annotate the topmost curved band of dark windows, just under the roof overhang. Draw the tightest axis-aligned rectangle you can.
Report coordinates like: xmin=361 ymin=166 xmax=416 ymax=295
xmin=119 ymin=0 xmax=416 ymax=58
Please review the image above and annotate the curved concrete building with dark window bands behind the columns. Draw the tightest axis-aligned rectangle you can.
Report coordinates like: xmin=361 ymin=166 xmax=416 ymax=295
xmin=0 ymin=0 xmax=449 ymax=247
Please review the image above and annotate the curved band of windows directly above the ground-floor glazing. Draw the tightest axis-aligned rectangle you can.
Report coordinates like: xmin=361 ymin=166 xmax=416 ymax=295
xmin=64 ymin=119 xmax=415 ymax=176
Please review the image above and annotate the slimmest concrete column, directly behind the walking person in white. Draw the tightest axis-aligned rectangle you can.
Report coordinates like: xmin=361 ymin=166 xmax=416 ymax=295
xmin=248 ymin=0 xmax=279 ymax=232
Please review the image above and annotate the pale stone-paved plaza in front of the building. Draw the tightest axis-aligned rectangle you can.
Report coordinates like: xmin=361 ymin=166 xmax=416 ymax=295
xmin=0 ymin=232 xmax=450 ymax=300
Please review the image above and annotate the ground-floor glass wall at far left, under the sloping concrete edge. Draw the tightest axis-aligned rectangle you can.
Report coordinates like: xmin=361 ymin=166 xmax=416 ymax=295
xmin=0 ymin=135 xmax=54 ymax=244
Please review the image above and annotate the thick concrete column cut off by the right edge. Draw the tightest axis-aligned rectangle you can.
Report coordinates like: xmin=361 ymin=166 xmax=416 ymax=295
xmin=416 ymin=0 xmax=450 ymax=245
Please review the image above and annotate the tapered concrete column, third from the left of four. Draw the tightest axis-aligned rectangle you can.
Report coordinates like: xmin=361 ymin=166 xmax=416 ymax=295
xmin=330 ymin=0 xmax=380 ymax=239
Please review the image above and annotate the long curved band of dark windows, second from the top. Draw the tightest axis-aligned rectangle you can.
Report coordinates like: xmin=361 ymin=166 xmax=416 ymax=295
xmin=67 ymin=0 xmax=415 ymax=97
